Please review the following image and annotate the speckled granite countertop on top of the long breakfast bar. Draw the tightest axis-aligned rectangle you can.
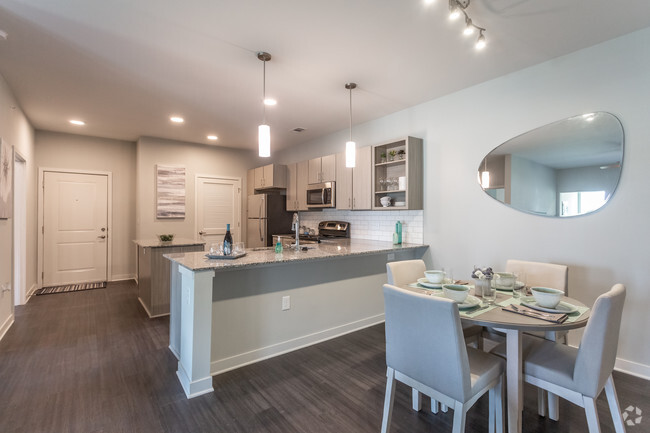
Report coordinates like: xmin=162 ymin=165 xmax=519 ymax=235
xmin=163 ymin=239 xmax=429 ymax=271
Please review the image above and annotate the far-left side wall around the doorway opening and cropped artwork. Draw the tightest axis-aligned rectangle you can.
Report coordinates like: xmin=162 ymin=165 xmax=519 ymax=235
xmin=0 ymin=76 xmax=36 ymax=338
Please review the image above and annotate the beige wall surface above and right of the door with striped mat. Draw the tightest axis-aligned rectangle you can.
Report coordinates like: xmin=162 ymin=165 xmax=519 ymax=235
xmin=35 ymin=131 xmax=136 ymax=280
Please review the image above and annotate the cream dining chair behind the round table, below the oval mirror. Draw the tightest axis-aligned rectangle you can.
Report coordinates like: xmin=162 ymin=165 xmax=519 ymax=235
xmin=485 ymin=259 xmax=569 ymax=421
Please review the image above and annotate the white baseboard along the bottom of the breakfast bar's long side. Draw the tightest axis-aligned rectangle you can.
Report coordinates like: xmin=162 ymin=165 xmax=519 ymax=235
xmin=210 ymin=314 xmax=385 ymax=376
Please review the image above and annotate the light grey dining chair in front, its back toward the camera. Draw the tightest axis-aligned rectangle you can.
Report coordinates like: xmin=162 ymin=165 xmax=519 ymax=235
xmin=381 ymin=284 xmax=504 ymax=433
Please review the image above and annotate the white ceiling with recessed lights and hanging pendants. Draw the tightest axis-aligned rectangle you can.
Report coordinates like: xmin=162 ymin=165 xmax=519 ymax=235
xmin=0 ymin=0 xmax=650 ymax=150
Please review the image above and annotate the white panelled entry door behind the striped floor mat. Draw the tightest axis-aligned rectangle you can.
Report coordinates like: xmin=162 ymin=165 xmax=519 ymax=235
xmin=43 ymin=171 xmax=109 ymax=286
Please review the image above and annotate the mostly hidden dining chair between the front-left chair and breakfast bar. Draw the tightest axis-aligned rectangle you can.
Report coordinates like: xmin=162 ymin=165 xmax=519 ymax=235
xmin=386 ymin=259 xmax=483 ymax=413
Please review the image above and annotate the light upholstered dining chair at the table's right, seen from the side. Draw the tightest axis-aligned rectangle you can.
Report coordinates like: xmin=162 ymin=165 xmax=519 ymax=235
xmin=524 ymin=284 xmax=625 ymax=433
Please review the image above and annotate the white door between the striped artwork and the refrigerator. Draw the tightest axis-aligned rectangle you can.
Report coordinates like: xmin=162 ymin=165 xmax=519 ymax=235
xmin=196 ymin=177 xmax=242 ymax=248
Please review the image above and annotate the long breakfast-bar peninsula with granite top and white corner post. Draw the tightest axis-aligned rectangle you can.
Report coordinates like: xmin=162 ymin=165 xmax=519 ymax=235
xmin=165 ymin=239 xmax=428 ymax=398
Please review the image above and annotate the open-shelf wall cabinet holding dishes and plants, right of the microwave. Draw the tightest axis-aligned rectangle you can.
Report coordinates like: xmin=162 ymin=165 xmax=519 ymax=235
xmin=372 ymin=137 xmax=424 ymax=210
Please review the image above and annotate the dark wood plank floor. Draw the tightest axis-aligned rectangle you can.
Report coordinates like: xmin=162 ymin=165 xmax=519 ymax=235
xmin=0 ymin=282 xmax=650 ymax=433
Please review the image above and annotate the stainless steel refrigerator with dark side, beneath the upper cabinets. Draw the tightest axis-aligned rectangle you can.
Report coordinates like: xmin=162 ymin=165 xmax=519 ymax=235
xmin=246 ymin=194 xmax=293 ymax=248
